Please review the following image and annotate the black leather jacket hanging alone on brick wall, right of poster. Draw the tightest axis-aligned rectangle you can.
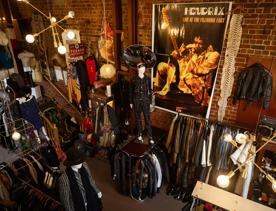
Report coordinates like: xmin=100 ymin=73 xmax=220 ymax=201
xmin=235 ymin=63 xmax=272 ymax=109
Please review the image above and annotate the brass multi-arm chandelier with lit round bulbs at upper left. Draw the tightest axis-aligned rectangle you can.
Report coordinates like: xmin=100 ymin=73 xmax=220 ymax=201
xmin=17 ymin=0 xmax=76 ymax=54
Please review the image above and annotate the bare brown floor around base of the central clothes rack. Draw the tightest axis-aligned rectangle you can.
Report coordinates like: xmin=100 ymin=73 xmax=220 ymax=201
xmin=87 ymin=158 xmax=184 ymax=211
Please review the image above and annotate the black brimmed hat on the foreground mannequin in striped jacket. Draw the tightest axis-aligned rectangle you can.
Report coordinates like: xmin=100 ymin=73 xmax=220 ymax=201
xmin=64 ymin=147 xmax=86 ymax=166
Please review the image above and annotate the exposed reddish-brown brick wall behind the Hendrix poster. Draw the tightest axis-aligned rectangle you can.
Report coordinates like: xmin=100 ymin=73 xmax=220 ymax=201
xmin=15 ymin=0 xmax=276 ymax=127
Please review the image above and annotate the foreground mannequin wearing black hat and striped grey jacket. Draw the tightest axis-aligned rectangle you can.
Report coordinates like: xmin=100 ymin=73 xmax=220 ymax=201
xmin=58 ymin=147 xmax=102 ymax=211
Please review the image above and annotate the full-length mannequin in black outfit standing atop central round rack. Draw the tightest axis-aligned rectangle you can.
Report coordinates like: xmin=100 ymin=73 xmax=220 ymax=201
xmin=130 ymin=63 xmax=154 ymax=144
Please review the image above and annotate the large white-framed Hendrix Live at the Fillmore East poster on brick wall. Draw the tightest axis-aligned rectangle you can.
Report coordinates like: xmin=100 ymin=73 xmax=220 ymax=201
xmin=152 ymin=2 xmax=231 ymax=117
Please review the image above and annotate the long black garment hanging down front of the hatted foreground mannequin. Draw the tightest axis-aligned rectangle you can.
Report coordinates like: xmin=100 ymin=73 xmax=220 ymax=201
xmin=66 ymin=166 xmax=102 ymax=211
